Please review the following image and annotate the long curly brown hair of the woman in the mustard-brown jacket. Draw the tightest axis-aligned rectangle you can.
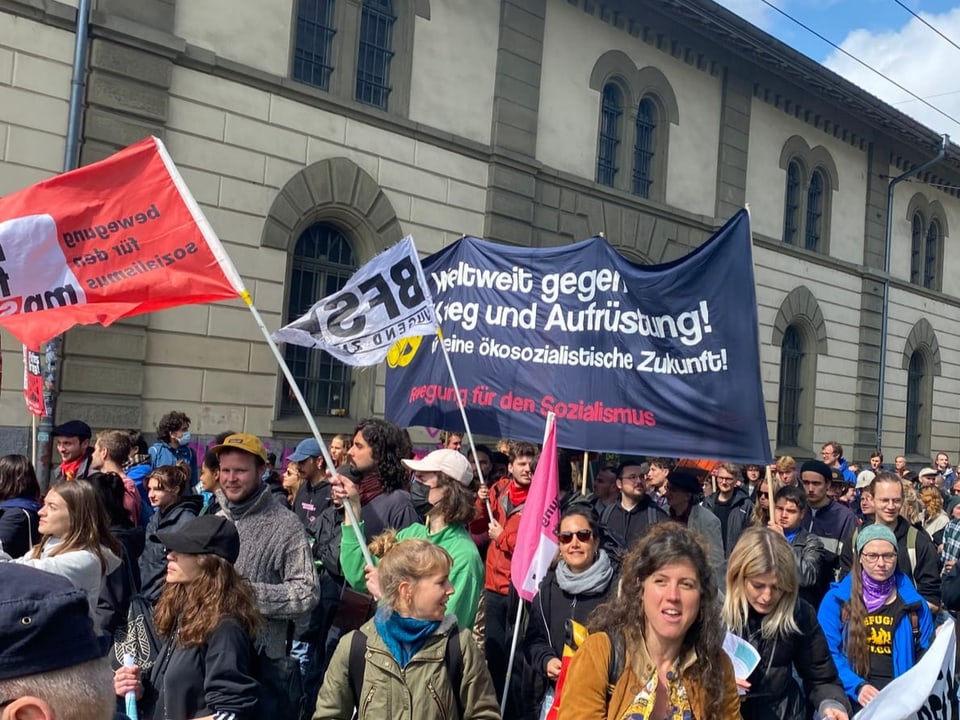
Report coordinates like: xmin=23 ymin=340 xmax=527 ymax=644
xmin=588 ymin=520 xmax=736 ymax=718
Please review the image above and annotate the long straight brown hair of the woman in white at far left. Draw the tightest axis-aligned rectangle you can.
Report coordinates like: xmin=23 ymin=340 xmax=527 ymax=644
xmin=32 ymin=480 xmax=123 ymax=572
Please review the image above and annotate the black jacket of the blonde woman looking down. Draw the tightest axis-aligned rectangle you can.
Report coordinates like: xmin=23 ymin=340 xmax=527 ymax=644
xmin=740 ymin=600 xmax=852 ymax=720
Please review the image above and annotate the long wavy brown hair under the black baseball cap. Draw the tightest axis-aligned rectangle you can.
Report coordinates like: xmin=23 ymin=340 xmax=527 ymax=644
xmin=153 ymin=554 xmax=262 ymax=647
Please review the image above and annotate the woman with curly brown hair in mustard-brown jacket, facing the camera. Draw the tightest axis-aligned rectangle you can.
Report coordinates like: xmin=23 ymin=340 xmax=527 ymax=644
xmin=559 ymin=523 xmax=740 ymax=720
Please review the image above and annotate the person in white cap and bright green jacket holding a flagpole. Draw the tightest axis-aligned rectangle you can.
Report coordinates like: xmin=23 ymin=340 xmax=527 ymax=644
xmin=340 ymin=449 xmax=484 ymax=628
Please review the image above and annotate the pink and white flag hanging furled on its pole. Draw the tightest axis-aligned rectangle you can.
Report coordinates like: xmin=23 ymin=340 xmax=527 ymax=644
xmin=510 ymin=413 xmax=560 ymax=600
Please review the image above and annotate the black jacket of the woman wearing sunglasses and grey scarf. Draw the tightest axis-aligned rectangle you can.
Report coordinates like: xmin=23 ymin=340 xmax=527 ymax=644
xmin=523 ymin=570 xmax=619 ymax=677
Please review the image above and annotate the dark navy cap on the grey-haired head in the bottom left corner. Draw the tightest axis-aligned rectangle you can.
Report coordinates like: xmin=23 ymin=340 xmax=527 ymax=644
xmin=0 ymin=563 xmax=103 ymax=680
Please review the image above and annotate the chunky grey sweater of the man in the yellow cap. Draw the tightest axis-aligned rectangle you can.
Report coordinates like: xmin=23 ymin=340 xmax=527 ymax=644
xmin=218 ymin=486 xmax=318 ymax=658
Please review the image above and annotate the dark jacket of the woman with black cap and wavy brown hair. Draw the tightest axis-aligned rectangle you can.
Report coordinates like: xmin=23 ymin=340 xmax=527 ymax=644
xmin=141 ymin=617 xmax=258 ymax=720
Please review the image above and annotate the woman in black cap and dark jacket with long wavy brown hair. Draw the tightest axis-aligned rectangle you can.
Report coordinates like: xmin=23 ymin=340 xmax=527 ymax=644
xmin=113 ymin=515 xmax=260 ymax=720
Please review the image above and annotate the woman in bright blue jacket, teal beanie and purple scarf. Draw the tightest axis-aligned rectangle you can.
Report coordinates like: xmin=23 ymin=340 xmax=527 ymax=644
xmin=817 ymin=524 xmax=934 ymax=709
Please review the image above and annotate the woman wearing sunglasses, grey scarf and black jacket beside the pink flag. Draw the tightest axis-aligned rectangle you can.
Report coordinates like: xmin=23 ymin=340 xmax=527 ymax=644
xmin=523 ymin=505 xmax=618 ymax=720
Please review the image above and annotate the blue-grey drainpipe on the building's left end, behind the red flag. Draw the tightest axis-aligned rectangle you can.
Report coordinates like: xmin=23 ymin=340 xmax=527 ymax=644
xmin=36 ymin=0 xmax=92 ymax=492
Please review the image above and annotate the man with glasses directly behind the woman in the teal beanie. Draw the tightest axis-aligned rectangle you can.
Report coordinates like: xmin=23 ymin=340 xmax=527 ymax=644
xmin=843 ymin=472 xmax=941 ymax=613
